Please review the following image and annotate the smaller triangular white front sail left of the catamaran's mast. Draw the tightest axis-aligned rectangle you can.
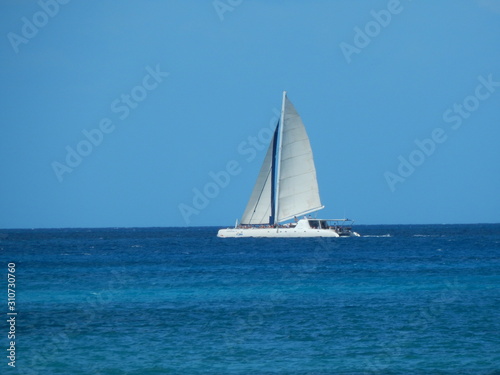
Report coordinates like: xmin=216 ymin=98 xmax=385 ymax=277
xmin=241 ymin=129 xmax=276 ymax=224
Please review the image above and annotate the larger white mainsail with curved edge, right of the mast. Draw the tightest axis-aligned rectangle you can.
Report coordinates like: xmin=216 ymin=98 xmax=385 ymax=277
xmin=276 ymin=94 xmax=323 ymax=222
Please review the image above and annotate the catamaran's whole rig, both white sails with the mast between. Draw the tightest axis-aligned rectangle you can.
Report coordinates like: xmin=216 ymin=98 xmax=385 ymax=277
xmin=241 ymin=92 xmax=323 ymax=224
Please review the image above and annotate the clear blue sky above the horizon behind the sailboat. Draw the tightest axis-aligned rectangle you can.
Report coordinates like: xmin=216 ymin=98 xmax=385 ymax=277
xmin=0 ymin=0 xmax=500 ymax=228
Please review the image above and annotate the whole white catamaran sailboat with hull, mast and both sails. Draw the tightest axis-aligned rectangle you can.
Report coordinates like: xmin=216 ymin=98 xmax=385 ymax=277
xmin=217 ymin=91 xmax=359 ymax=238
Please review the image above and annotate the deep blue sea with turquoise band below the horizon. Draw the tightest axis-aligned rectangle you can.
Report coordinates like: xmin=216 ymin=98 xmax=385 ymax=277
xmin=0 ymin=224 xmax=500 ymax=375
